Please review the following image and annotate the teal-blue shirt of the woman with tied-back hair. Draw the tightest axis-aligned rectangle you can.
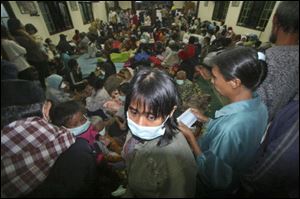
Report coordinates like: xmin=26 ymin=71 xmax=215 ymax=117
xmin=197 ymin=96 xmax=268 ymax=194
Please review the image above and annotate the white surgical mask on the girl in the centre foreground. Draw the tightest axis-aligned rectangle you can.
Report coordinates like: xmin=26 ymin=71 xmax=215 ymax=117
xmin=126 ymin=112 xmax=169 ymax=140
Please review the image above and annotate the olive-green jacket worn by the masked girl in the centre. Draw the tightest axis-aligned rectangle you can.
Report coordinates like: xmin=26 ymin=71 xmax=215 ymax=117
xmin=123 ymin=133 xmax=197 ymax=198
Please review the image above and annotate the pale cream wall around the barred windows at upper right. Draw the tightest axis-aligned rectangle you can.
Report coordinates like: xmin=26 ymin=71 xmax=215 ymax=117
xmin=198 ymin=1 xmax=279 ymax=42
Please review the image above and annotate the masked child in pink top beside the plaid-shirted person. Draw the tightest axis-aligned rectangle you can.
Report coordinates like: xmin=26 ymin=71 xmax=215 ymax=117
xmin=50 ymin=100 xmax=122 ymax=162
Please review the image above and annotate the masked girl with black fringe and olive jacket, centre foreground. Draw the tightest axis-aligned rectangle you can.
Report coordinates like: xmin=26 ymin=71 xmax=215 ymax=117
xmin=122 ymin=68 xmax=196 ymax=197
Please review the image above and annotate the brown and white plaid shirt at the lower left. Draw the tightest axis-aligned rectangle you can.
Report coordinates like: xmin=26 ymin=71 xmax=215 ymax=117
xmin=1 ymin=117 xmax=75 ymax=198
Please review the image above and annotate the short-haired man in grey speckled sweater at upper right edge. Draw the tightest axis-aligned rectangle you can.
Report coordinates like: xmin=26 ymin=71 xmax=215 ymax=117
xmin=257 ymin=1 xmax=299 ymax=121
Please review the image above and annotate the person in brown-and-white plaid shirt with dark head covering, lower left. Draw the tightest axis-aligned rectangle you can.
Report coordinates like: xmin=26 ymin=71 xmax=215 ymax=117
xmin=1 ymin=80 xmax=75 ymax=197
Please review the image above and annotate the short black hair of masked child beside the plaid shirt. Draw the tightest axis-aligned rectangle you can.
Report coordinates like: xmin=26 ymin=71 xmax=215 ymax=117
xmin=49 ymin=100 xmax=85 ymax=126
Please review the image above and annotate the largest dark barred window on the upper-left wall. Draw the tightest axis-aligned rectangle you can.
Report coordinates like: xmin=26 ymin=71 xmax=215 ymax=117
xmin=38 ymin=1 xmax=73 ymax=35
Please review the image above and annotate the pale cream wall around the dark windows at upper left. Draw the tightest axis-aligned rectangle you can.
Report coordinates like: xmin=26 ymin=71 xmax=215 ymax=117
xmin=9 ymin=1 xmax=107 ymax=44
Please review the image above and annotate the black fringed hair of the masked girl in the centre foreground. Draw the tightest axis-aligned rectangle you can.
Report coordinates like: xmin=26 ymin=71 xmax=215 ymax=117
xmin=125 ymin=68 xmax=180 ymax=146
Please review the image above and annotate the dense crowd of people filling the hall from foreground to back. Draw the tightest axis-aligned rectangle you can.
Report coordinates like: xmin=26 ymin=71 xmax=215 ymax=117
xmin=1 ymin=1 xmax=299 ymax=197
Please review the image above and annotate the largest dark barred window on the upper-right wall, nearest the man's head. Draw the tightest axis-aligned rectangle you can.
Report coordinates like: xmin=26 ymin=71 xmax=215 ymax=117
xmin=237 ymin=1 xmax=276 ymax=31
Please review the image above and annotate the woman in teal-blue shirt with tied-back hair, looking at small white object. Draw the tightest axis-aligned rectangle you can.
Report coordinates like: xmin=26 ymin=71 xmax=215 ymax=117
xmin=180 ymin=47 xmax=268 ymax=197
